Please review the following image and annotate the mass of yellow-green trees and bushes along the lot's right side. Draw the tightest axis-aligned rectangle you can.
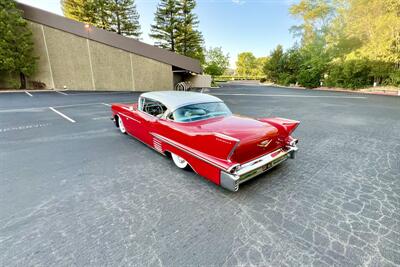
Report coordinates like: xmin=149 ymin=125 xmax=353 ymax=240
xmin=264 ymin=0 xmax=400 ymax=88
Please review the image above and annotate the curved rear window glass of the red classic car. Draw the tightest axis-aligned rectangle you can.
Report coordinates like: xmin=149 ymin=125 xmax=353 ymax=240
xmin=169 ymin=102 xmax=232 ymax=122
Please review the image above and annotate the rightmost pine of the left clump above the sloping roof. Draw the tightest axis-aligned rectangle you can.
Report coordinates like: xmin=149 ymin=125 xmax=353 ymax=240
xmin=111 ymin=0 xmax=141 ymax=38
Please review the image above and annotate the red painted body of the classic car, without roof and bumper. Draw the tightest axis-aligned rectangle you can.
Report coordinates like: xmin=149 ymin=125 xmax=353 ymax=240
xmin=111 ymin=95 xmax=299 ymax=192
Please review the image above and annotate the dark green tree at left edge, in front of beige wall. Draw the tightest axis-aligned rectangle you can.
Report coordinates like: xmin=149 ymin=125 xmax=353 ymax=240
xmin=0 ymin=0 xmax=37 ymax=88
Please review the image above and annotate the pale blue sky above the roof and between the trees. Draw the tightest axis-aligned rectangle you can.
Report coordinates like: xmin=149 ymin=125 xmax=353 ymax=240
xmin=18 ymin=0 xmax=299 ymax=68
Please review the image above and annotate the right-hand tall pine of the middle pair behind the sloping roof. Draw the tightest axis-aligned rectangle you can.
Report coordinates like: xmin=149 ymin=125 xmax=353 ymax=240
xmin=176 ymin=0 xmax=204 ymax=62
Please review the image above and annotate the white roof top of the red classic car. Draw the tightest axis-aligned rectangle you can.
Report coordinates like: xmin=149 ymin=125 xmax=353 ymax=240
xmin=140 ymin=91 xmax=223 ymax=111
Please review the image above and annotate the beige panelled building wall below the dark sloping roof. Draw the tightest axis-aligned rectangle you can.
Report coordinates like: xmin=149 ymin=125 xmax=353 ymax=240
xmin=25 ymin=22 xmax=173 ymax=91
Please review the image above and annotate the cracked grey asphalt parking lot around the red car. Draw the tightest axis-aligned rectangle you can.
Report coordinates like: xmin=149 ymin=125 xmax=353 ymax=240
xmin=0 ymin=84 xmax=400 ymax=266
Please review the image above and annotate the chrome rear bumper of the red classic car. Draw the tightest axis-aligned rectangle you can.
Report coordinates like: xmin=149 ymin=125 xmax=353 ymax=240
xmin=220 ymin=140 xmax=298 ymax=192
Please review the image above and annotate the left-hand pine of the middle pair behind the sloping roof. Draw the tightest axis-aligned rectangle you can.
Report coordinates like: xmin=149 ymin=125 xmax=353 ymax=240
xmin=150 ymin=0 xmax=179 ymax=52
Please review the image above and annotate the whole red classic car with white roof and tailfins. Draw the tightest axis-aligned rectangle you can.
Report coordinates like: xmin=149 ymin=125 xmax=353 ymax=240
xmin=111 ymin=91 xmax=299 ymax=191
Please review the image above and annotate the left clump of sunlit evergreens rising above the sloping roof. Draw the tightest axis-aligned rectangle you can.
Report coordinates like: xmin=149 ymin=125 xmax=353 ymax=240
xmin=61 ymin=0 xmax=141 ymax=38
